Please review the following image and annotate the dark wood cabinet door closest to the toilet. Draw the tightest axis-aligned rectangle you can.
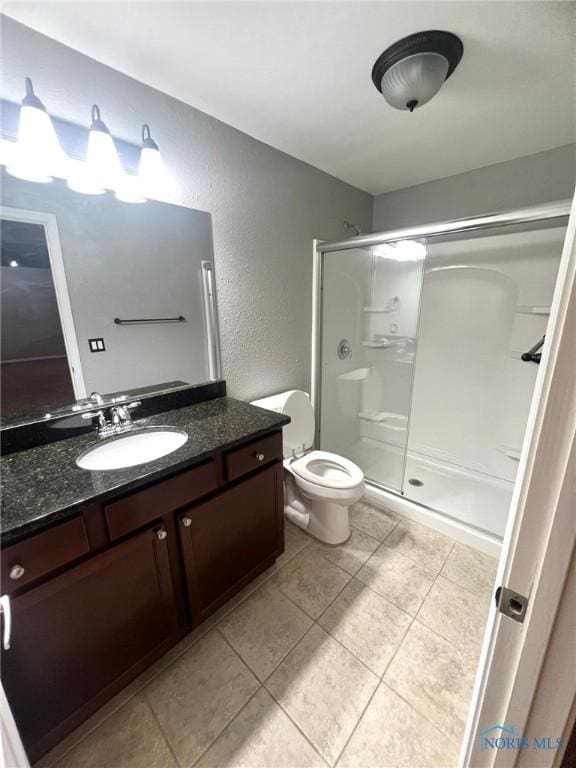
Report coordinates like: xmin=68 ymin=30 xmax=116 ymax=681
xmin=179 ymin=464 xmax=284 ymax=622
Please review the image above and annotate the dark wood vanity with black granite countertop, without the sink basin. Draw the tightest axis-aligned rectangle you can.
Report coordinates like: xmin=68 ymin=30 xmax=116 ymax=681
xmin=2 ymin=397 xmax=288 ymax=760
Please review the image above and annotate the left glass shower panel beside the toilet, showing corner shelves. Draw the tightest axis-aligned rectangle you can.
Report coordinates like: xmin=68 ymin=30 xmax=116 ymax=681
xmin=319 ymin=240 xmax=426 ymax=492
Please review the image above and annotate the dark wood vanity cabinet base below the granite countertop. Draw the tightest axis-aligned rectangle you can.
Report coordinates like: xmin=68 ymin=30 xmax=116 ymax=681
xmin=1 ymin=431 xmax=284 ymax=760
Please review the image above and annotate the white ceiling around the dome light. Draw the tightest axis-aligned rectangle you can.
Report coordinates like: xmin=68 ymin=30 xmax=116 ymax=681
xmin=3 ymin=0 xmax=576 ymax=194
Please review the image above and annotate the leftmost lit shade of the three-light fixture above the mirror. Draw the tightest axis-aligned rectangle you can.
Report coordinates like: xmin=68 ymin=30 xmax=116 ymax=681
xmin=6 ymin=77 xmax=67 ymax=183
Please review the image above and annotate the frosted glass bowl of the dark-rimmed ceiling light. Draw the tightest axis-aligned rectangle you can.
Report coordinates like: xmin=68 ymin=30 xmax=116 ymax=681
xmin=381 ymin=53 xmax=449 ymax=110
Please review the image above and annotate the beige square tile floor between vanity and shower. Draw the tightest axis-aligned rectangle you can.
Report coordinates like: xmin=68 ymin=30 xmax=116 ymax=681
xmin=40 ymin=502 xmax=496 ymax=768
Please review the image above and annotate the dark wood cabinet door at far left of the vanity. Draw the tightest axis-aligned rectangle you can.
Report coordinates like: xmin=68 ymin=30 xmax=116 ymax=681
xmin=2 ymin=529 xmax=177 ymax=760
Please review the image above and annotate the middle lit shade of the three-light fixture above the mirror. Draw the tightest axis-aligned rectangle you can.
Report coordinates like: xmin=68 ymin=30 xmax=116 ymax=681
xmin=68 ymin=104 xmax=124 ymax=195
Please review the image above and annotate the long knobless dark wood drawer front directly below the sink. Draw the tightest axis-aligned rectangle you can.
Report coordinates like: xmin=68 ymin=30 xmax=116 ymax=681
xmin=104 ymin=460 xmax=218 ymax=540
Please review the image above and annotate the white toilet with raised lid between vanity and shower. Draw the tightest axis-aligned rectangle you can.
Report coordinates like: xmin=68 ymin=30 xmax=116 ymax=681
xmin=252 ymin=389 xmax=364 ymax=544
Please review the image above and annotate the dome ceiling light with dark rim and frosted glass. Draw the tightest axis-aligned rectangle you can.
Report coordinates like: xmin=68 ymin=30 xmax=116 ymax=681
xmin=372 ymin=30 xmax=464 ymax=112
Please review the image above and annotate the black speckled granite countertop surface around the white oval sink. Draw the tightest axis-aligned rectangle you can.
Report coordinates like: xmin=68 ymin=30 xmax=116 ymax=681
xmin=0 ymin=397 xmax=290 ymax=544
